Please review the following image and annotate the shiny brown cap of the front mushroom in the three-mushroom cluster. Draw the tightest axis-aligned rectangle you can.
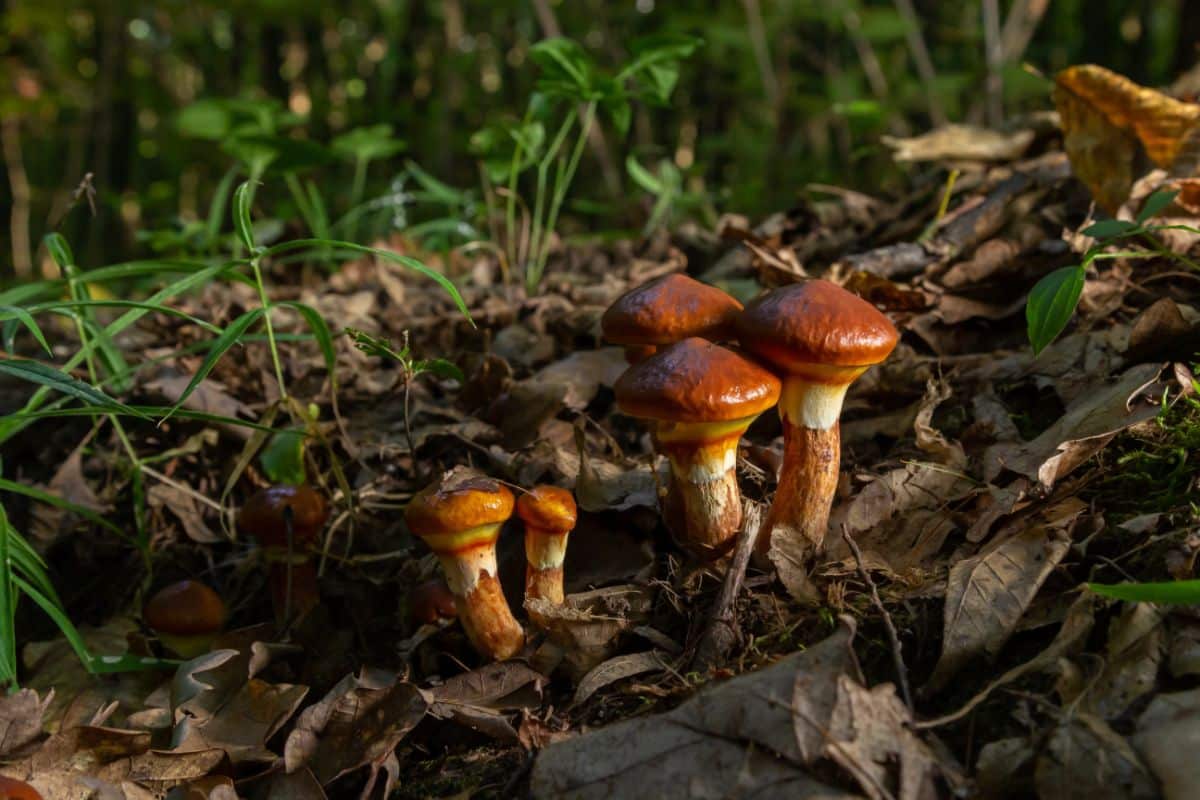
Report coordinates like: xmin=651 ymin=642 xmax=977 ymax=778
xmin=613 ymin=337 xmax=780 ymax=422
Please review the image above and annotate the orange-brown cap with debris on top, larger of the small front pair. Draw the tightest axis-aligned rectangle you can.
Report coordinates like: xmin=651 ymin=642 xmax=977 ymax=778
xmin=404 ymin=470 xmax=514 ymax=537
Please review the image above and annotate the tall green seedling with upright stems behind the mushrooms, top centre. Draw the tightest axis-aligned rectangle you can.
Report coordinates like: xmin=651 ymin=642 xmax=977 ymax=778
xmin=473 ymin=36 xmax=701 ymax=294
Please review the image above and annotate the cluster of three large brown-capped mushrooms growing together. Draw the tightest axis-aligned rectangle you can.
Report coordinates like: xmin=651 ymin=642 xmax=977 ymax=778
xmin=601 ymin=273 xmax=899 ymax=559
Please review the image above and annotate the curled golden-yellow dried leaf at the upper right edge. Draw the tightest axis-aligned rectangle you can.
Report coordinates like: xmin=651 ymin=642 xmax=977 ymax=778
xmin=1054 ymin=64 xmax=1200 ymax=212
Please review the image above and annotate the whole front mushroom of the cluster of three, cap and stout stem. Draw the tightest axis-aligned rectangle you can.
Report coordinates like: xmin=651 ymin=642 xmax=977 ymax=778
xmin=614 ymin=337 xmax=780 ymax=559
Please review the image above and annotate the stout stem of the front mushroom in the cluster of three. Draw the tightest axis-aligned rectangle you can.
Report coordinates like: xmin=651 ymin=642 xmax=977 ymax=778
xmin=655 ymin=414 xmax=757 ymax=560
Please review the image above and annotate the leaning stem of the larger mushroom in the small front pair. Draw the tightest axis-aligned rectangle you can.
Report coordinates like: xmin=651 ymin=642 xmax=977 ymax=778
xmin=425 ymin=524 xmax=524 ymax=660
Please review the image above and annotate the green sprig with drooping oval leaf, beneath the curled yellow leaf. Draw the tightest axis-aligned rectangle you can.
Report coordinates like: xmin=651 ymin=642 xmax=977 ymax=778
xmin=1025 ymin=190 xmax=1200 ymax=355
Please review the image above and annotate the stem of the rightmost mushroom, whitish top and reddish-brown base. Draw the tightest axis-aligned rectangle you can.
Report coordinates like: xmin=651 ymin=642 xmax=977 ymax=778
xmin=756 ymin=369 xmax=863 ymax=555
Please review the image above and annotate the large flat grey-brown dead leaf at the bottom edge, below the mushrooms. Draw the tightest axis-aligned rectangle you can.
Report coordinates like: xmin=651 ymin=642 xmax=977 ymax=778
xmin=530 ymin=621 xmax=857 ymax=800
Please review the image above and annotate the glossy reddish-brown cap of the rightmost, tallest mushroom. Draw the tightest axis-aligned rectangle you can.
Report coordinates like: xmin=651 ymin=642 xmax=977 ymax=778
xmin=737 ymin=281 xmax=900 ymax=377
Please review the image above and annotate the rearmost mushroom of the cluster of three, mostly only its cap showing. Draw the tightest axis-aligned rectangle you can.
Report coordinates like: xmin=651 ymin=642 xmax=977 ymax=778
xmin=600 ymin=272 xmax=742 ymax=363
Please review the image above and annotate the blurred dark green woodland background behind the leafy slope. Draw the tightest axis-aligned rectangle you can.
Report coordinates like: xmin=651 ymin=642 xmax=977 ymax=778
xmin=0 ymin=0 xmax=1200 ymax=279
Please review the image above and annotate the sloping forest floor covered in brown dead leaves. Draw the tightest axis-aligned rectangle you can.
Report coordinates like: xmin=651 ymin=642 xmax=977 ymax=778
xmin=0 ymin=90 xmax=1200 ymax=800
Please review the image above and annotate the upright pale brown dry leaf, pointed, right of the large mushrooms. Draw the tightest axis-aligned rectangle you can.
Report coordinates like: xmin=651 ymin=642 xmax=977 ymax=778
xmin=926 ymin=500 xmax=1085 ymax=691
